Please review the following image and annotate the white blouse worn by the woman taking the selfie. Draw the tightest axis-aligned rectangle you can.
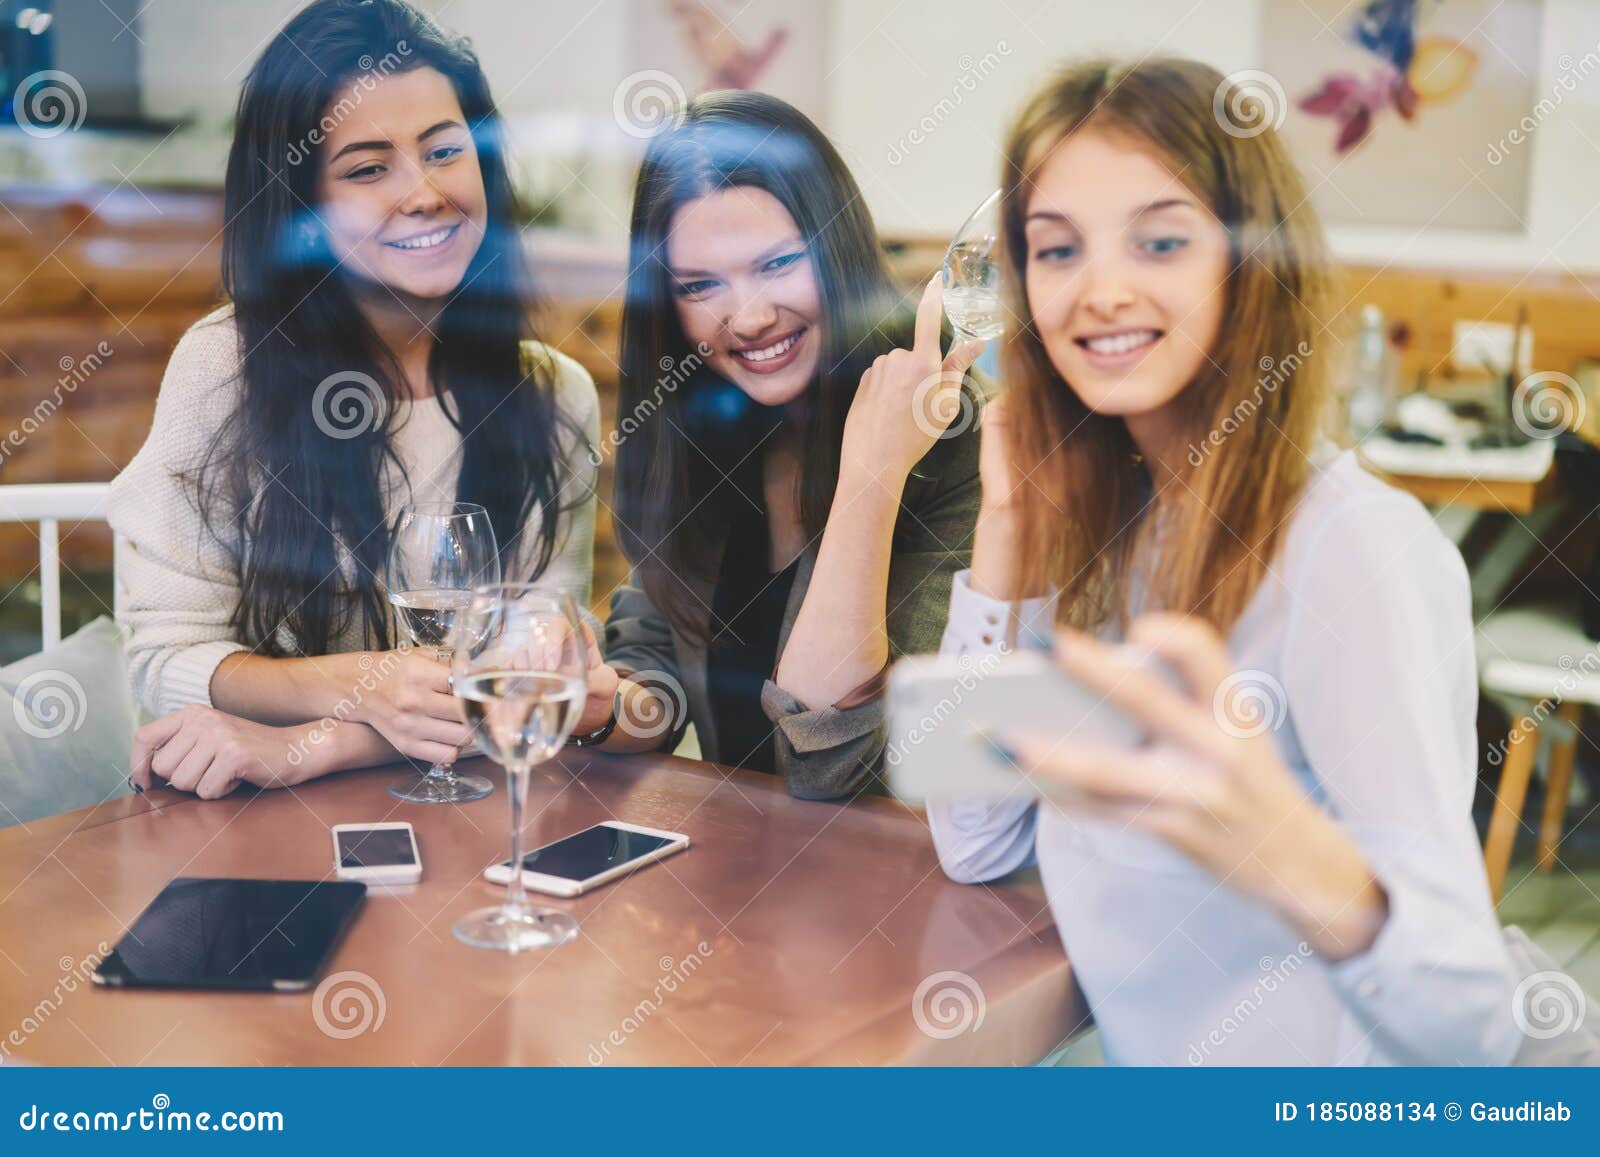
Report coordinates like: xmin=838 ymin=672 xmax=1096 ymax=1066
xmin=928 ymin=453 xmax=1522 ymax=1064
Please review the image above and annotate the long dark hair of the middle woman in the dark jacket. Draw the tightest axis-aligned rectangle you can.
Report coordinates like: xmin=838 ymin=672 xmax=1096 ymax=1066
xmin=614 ymin=91 xmax=907 ymax=637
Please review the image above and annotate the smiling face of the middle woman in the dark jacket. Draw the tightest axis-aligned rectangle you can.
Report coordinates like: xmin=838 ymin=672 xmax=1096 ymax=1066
xmin=666 ymin=186 xmax=822 ymax=406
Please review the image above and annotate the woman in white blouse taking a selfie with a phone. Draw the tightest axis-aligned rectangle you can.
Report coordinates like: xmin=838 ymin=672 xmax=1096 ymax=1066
xmin=930 ymin=59 xmax=1522 ymax=1064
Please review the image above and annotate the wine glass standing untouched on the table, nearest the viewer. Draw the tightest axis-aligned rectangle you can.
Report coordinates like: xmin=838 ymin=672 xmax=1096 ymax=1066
xmin=451 ymin=584 xmax=589 ymax=952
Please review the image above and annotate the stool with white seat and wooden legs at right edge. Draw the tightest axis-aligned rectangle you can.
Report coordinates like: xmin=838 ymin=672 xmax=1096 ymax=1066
xmin=1477 ymin=602 xmax=1600 ymax=903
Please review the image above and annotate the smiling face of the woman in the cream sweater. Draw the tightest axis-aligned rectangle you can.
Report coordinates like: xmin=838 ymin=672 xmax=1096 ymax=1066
xmin=317 ymin=69 xmax=488 ymax=301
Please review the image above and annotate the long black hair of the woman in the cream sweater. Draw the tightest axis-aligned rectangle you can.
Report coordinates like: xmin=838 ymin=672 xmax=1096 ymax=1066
xmin=194 ymin=0 xmax=570 ymax=656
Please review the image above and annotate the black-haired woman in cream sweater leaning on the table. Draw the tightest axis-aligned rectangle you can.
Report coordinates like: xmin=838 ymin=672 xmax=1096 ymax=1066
xmin=110 ymin=0 xmax=598 ymax=799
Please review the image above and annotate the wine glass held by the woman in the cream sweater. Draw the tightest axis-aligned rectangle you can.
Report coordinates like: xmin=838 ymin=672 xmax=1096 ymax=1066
xmin=387 ymin=502 xmax=501 ymax=803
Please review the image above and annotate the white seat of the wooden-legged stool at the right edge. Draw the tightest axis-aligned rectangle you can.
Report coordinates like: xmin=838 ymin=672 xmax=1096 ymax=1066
xmin=1477 ymin=602 xmax=1600 ymax=704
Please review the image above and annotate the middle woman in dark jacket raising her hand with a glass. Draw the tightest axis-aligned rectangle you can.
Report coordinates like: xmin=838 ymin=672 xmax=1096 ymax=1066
xmin=578 ymin=93 xmax=981 ymax=799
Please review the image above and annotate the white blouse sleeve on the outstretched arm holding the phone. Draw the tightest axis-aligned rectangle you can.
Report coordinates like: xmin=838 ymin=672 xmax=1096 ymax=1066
xmin=1283 ymin=496 xmax=1522 ymax=1064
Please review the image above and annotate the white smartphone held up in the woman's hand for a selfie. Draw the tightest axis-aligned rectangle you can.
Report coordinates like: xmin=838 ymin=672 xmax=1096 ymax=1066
xmin=883 ymin=651 xmax=1176 ymax=803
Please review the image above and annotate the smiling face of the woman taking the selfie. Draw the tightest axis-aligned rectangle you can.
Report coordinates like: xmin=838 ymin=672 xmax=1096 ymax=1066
xmin=1026 ymin=130 xmax=1230 ymax=435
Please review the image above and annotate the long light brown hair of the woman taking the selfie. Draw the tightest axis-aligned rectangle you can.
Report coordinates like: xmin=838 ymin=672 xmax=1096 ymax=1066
xmin=1002 ymin=59 xmax=1331 ymax=632
